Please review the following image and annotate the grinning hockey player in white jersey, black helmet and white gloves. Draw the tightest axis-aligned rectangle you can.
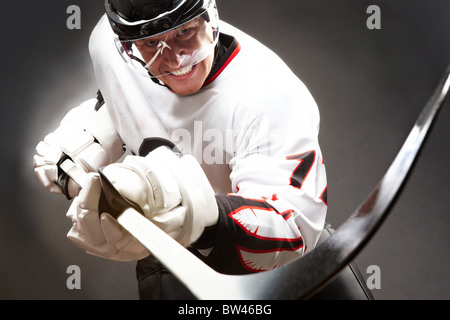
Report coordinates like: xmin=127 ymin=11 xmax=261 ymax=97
xmin=34 ymin=0 xmax=327 ymax=299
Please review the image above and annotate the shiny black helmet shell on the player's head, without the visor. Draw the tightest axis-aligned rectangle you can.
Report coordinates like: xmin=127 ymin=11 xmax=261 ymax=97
xmin=105 ymin=0 xmax=215 ymax=40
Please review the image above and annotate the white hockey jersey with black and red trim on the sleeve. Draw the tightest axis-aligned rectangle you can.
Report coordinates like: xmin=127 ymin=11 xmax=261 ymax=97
xmin=89 ymin=16 xmax=327 ymax=273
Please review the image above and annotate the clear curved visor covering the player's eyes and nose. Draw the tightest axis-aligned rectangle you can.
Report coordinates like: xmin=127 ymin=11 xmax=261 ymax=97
xmin=116 ymin=10 xmax=219 ymax=78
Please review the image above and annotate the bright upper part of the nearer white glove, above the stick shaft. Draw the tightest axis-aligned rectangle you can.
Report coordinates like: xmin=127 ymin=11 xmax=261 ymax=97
xmin=102 ymin=147 xmax=218 ymax=247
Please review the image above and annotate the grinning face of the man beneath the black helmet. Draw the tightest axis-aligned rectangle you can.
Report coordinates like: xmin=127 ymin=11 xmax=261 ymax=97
xmin=134 ymin=17 xmax=214 ymax=96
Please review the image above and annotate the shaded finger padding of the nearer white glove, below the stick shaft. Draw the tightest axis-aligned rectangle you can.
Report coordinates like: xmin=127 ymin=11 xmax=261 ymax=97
xmin=67 ymin=173 xmax=150 ymax=262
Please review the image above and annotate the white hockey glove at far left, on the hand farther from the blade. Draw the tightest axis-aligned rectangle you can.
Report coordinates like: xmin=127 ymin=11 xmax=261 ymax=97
xmin=33 ymin=99 xmax=124 ymax=199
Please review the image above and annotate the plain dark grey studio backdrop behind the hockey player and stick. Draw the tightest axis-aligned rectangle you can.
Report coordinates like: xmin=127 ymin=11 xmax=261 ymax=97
xmin=0 ymin=0 xmax=450 ymax=299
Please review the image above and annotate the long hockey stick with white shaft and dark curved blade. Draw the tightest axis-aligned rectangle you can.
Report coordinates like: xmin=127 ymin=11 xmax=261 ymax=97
xmin=63 ymin=66 xmax=450 ymax=300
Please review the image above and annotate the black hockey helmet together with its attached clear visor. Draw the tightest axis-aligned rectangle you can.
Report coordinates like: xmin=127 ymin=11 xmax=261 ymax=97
xmin=105 ymin=0 xmax=219 ymax=78
